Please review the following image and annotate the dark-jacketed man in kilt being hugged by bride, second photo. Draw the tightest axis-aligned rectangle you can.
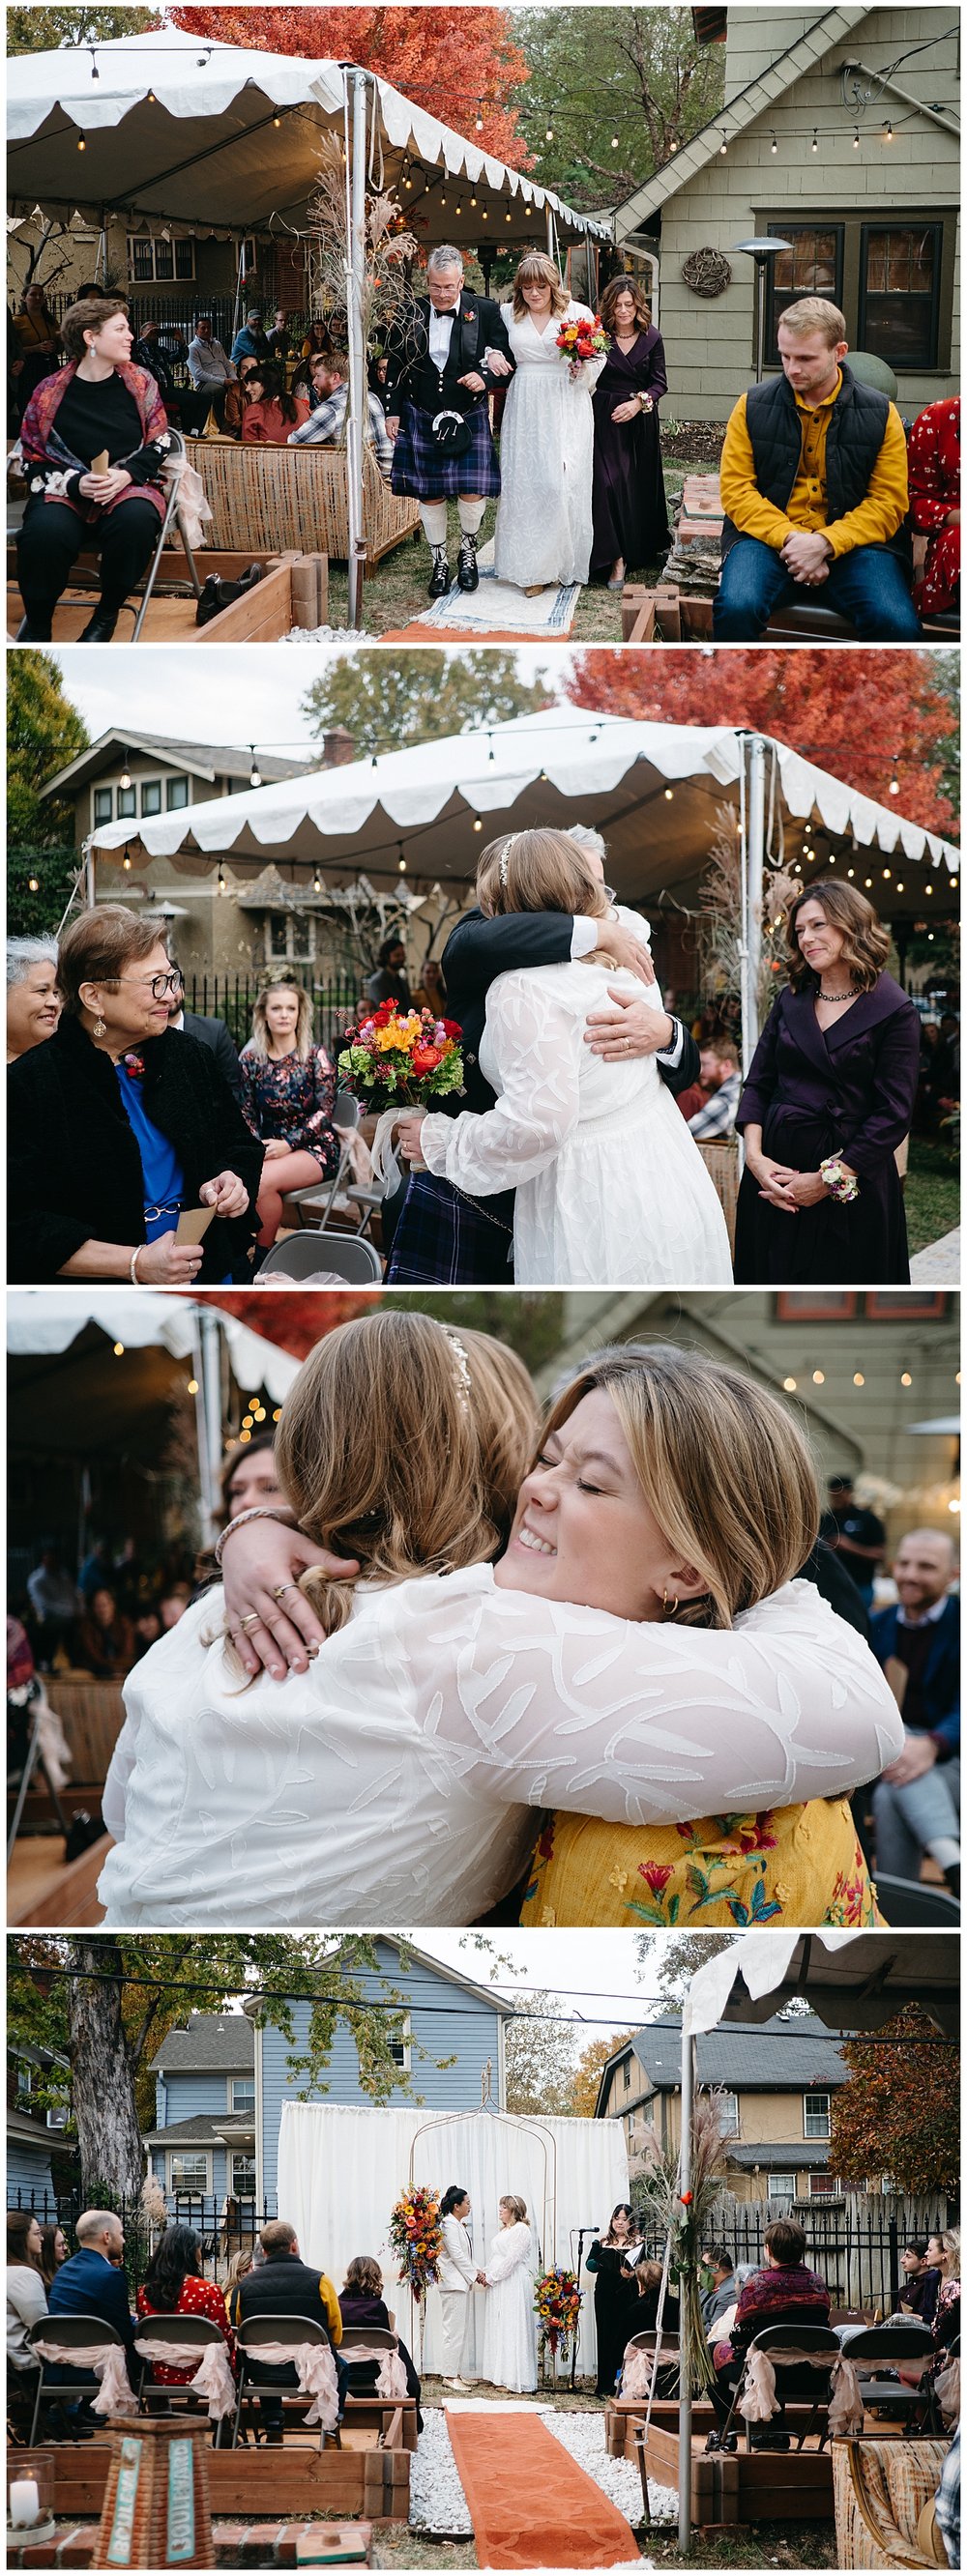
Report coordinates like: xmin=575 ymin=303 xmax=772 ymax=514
xmin=384 ymin=896 xmax=699 ymax=1288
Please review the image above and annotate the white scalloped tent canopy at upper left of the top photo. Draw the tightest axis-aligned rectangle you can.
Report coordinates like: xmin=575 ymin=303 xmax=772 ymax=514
xmin=8 ymin=26 xmax=611 ymax=245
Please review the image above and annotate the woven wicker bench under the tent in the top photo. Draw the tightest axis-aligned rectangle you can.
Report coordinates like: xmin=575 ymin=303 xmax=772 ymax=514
xmin=186 ymin=438 xmax=421 ymax=564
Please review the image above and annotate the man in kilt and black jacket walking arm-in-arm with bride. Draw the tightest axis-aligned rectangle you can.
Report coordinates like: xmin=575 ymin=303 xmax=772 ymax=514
xmin=384 ymin=243 xmax=513 ymax=600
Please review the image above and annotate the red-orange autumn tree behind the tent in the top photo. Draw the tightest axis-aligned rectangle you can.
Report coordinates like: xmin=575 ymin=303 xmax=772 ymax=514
xmin=170 ymin=8 xmax=531 ymax=170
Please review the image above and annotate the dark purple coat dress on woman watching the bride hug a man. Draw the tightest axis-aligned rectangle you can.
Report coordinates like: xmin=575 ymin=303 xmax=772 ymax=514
xmin=735 ymin=973 xmax=921 ymax=1288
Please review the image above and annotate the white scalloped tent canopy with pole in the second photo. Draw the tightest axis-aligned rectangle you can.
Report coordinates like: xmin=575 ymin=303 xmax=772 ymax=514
xmin=88 ymin=706 xmax=959 ymax=1061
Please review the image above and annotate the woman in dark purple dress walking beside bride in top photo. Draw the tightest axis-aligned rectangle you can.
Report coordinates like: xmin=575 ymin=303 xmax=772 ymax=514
xmin=591 ymin=278 xmax=668 ymax=590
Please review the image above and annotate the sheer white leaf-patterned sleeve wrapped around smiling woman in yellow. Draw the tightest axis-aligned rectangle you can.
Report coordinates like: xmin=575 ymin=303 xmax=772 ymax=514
xmin=405 ymin=1581 xmax=902 ymax=1824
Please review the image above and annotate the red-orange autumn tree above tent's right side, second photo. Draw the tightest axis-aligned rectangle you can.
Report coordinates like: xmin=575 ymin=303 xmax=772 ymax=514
xmin=568 ymin=644 xmax=956 ymax=837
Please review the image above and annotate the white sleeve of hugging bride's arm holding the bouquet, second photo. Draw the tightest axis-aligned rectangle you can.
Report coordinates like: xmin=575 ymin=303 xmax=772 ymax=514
xmin=421 ymin=971 xmax=591 ymax=1198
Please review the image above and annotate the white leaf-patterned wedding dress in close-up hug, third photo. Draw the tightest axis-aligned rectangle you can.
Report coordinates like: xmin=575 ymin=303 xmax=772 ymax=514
xmin=98 ymin=1566 xmax=902 ymax=1929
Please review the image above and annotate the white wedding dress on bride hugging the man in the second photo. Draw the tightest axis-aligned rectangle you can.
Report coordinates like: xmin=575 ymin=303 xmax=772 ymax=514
xmin=421 ymin=961 xmax=732 ymax=1288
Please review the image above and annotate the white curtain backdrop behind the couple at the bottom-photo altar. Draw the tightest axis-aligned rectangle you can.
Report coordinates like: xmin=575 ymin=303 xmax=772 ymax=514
xmin=278 ymin=2102 xmax=630 ymax=2378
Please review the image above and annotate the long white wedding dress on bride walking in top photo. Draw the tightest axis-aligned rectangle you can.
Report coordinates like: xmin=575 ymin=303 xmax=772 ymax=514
xmin=492 ymin=304 xmax=606 ymax=590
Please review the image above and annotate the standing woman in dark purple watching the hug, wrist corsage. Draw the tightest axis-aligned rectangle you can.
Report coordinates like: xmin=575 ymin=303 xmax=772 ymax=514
xmin=735 ymin=879 xmax=921 ymax=1288
